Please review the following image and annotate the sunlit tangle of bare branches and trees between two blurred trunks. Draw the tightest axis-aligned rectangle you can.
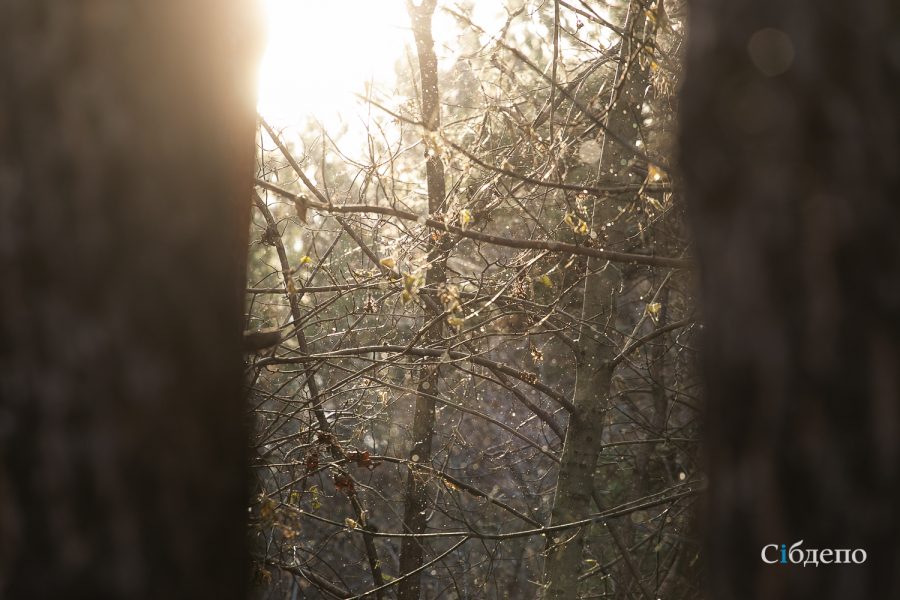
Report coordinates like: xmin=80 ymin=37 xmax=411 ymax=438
xmin=247 ymin=1 xmax=703 ymax=599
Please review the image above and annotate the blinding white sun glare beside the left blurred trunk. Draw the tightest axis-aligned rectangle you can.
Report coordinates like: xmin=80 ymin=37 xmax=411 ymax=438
xmin=258 ymin=0 xmax=409 ymax=126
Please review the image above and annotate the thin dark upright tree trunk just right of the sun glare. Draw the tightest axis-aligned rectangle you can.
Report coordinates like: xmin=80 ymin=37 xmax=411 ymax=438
xmin=397 ymin=0 xmax=449 ymax=600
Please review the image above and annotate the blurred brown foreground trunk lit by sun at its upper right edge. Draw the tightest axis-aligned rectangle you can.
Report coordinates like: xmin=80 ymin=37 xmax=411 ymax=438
xmin=0 ymin=0 xmax=260 ymax=599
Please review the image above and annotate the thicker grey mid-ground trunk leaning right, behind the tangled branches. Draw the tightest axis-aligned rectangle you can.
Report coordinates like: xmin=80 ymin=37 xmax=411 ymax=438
xmin=544 ymin=3 xmax=646 ymax=600
